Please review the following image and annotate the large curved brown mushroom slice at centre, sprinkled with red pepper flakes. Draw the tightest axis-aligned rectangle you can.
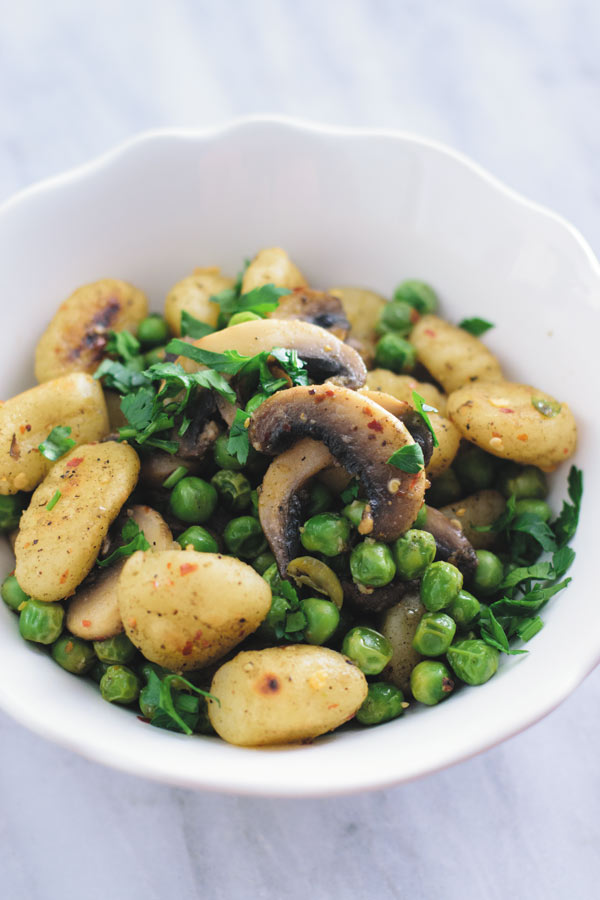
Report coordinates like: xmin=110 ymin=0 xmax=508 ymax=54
xmin=249 ymin=384 xmax=426 ymax=552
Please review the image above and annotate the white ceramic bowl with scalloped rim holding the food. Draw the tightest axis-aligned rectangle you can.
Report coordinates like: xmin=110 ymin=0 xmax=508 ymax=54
xmin=0 ymin=119 xmax=600 ymax=796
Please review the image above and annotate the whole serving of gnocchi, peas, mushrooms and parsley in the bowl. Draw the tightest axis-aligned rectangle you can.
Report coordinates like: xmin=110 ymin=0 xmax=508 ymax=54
xmin=0 ymin=247 xmax=583 ymax=747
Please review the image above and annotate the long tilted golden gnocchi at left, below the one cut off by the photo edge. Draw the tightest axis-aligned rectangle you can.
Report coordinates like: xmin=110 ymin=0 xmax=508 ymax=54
xmin=15 ymin=441 xmax=140 ymax=602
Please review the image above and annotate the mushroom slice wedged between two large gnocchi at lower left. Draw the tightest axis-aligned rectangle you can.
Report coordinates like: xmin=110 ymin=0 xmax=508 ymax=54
xmin=66 ymin=506 xmax=179 ymax=641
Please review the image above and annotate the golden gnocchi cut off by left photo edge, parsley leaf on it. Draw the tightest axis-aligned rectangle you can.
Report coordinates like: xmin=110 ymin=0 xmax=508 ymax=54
xmin=0 ymin=372 xmax=108 ymax=494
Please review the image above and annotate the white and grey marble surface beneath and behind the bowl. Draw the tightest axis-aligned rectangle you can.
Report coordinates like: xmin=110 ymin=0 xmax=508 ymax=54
xmin=0 ymin=0 xmax=600 ymax=900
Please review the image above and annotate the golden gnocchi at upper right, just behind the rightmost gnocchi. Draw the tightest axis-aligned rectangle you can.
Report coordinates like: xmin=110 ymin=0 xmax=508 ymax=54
xmin=410 ymin=315 xmax=502 ymax=394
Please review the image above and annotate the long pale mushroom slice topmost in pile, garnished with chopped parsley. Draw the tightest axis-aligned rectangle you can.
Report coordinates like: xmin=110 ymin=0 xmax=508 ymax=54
xmin=179 ymin=319 xmax=367 ymax=388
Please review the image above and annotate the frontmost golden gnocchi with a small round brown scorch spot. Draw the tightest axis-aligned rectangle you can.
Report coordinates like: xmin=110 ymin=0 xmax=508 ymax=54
xmin=208 ymin=644 xmax=368 ymax=747
